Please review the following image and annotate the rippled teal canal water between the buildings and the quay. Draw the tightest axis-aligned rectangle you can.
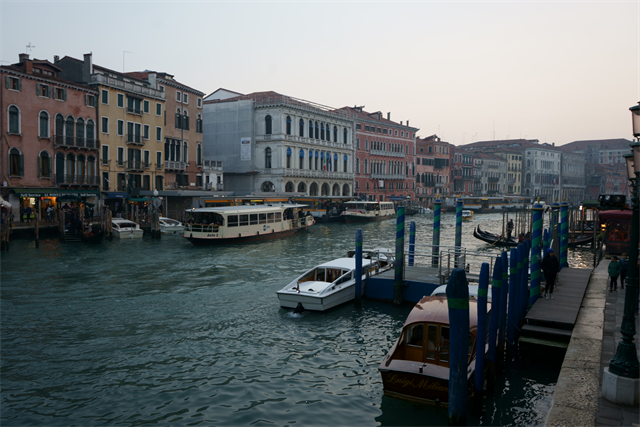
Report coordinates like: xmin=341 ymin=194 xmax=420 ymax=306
xmin=0 ymin=214 xmax=590 ymax=426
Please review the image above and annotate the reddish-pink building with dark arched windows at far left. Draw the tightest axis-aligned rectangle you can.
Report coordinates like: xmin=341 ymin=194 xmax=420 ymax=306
xmin=0 ymin=54 xmax=99 ymax=220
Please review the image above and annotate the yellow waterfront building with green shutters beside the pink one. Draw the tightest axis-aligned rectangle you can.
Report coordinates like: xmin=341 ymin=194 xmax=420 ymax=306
xmin=55 ymin=54 xmax=165 ymax=204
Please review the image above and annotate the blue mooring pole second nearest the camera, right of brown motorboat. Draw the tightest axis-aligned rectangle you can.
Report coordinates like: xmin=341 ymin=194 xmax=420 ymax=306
xmin=474 ymin=262 xmax=489 ymax=412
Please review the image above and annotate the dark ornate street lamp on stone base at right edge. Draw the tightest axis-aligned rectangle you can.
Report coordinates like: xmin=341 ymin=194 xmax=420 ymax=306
xmin=609 ymin=104 xmax=640 ymax=379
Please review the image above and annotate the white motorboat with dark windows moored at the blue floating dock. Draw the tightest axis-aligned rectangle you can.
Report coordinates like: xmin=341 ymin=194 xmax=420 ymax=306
xmin=276 ymin=257 xmax=392 ymax=311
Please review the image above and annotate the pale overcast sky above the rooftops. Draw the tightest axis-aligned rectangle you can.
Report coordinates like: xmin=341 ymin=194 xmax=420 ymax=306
xmin=0 ymin=0 xmax=640 ymax=145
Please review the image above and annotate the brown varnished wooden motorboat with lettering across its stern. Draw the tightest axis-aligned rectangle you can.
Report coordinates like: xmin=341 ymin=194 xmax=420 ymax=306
xmin=378 ymin=296 xmax=491 ymax=406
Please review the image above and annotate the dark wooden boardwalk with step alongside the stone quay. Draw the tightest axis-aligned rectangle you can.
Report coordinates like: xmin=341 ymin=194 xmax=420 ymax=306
xmin=519 ymin=268 xmax=593 ymax=348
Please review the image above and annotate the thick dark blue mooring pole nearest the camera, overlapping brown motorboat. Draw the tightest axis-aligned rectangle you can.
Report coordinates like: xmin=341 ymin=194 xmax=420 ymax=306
xmin=446 ymin=268 xmax=469 ymax=427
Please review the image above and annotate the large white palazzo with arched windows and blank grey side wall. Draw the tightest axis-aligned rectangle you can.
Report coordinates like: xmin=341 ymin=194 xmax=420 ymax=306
xmin=203 ymin=90 xmax=354 ymax=196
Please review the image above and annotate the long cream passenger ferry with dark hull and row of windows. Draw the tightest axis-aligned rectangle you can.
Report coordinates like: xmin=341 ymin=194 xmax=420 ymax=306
xmin=182 ymin=203 xmax=315 ymax=245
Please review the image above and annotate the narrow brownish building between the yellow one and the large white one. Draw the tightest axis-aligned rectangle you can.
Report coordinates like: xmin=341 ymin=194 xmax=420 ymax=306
xmin=126 ymin=71 xmax=206 ymax=190
